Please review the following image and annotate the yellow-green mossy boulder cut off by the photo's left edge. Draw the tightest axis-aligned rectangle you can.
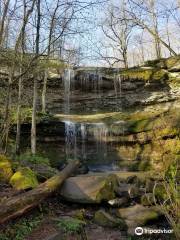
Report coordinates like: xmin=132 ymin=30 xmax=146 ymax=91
xmin=0 ymin=155 xmax=13 ymax=182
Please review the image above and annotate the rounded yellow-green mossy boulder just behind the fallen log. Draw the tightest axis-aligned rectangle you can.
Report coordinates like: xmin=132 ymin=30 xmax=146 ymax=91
xmin=10 ymin=167 xmax=38 ymax=190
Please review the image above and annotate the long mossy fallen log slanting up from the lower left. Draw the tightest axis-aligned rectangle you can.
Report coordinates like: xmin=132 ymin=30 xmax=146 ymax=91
xmin=0 ymin=161 xmax=79 ymax=224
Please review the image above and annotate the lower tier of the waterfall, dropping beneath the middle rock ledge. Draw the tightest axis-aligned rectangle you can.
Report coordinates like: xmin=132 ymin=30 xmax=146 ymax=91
xmin=64 ymin=121 xmax=108 ymax=161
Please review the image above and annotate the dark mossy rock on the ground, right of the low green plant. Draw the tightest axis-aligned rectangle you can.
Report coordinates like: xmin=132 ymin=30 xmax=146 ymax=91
xmin=94 ymin=210 xmax=126 ymax=230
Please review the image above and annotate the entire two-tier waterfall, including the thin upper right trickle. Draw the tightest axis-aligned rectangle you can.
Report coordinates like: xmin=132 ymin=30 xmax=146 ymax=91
xmin=63 ymin=69 xmax=121 ymax=171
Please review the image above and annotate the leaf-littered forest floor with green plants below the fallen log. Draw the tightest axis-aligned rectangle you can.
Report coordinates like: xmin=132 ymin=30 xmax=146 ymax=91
xmin=0 ymin=194 xmax=174 ymax=240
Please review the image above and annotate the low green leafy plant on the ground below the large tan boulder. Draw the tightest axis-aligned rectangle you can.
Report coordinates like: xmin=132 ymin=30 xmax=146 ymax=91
xmin=57 ymin=218 xmax=86 ymax=233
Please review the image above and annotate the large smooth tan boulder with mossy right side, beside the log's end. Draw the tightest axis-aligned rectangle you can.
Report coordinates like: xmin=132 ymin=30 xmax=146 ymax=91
xmin=61 ymin=174 xmax=117 ymax=203
